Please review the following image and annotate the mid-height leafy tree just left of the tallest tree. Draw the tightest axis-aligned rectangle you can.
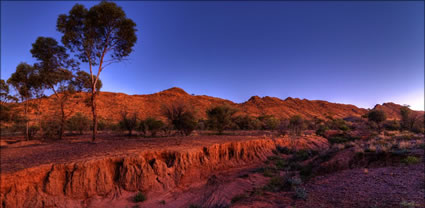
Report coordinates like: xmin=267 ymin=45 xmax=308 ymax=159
xmin=31 ymin=37 xmax=78 ymax=139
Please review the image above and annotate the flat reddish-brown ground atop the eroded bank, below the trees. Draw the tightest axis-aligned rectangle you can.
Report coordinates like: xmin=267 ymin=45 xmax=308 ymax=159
xmin=0 ymin=134 xmax=276 ymax=173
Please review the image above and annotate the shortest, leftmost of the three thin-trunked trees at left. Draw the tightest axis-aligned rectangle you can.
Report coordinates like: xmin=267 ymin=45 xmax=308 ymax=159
xmin=7 ymin=62 xmax=42 ymax=140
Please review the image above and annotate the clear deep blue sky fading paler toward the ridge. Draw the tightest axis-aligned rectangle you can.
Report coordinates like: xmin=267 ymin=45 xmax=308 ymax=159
xmin=1 ymin=1 xmax=424 ymax=110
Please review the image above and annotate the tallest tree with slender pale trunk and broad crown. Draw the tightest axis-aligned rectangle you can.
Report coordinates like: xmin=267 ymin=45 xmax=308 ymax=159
xmin=57 ymin=1 xmax=137 ymax=141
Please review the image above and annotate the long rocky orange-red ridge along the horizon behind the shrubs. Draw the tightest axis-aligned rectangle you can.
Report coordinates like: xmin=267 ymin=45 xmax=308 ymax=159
xmin=9 ymin=87 xmax=423 ymax=122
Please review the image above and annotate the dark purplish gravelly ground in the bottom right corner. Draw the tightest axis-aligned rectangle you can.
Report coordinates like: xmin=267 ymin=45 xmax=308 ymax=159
xmin=233 ymin=151 xmax=425 ymax=208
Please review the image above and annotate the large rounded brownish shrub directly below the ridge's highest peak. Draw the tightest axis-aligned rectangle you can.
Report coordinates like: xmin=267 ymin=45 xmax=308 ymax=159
xmin=162 ymin=103 xmax=198 ymax=136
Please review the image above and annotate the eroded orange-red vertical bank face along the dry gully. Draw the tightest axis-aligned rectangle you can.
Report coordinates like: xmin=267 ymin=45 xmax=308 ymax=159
xmin=0 ymin=137 xmax=328 ymax=208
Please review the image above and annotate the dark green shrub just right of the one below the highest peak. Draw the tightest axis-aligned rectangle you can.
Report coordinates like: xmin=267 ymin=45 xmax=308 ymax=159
xmin=207 ymin=105 xmax=236 ymax=134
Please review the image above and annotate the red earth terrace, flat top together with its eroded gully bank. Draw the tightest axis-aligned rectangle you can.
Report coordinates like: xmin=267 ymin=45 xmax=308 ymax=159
xmin=0 ymin=136 xmax=328 ymax=207
